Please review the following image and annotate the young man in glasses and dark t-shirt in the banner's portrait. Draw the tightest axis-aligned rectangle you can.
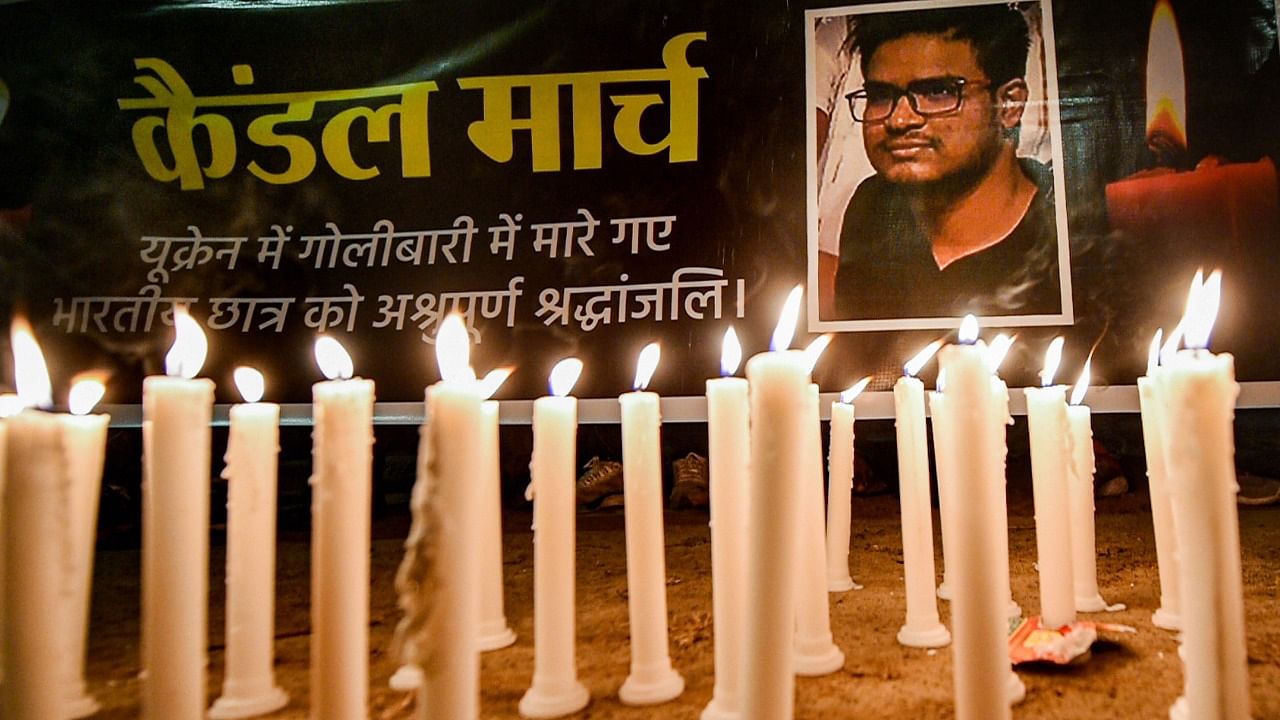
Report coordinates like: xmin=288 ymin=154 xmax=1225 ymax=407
xmin=836 ymin=4 xmax=1061 ymax=319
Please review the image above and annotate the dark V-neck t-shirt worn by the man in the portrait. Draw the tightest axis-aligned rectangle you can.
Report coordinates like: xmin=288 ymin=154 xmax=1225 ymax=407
xmin=836 ymin=159 xmax=1062 ymax=320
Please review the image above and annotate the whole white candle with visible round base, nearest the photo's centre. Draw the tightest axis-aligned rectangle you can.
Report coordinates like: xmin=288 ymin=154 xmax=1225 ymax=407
xmin=618 ymin=343 xmax=685 ymax=705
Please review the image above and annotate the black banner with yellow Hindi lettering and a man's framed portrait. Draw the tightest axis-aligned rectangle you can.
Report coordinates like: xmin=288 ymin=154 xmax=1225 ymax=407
xmin=0 ymin=0 xmax=1280 ymax=402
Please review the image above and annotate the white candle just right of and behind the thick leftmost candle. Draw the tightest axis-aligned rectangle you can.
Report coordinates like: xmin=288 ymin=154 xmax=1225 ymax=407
xmin=59 ymin=379 xmax=111 ymax=717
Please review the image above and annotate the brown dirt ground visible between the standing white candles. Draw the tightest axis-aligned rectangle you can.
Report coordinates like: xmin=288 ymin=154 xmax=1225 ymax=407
xmin=77 ymin=471 xmax=1280 ymax=720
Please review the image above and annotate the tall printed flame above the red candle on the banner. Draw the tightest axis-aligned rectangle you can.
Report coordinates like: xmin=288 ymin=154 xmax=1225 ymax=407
xmin=1147 ymin=0 xmax=1187 ymax=150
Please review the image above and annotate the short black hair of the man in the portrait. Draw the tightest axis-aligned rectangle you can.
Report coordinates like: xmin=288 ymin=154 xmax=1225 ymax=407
xmin=850 ymin=3 xmax=1030 ymax=87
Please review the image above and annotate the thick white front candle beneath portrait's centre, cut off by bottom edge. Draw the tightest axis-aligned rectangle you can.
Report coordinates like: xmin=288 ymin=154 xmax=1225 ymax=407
xmin=938 ymin=316 xmax=1010 ymax=720
